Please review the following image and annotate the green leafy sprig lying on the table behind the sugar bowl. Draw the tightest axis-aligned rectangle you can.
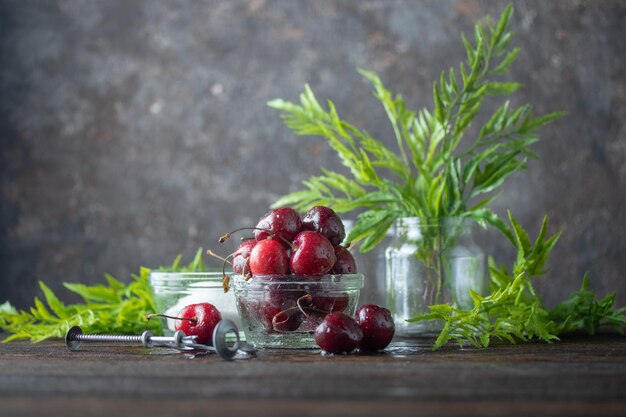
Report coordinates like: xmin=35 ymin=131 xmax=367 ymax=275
xmin=0 ymin=249 xmax=206 ymax=342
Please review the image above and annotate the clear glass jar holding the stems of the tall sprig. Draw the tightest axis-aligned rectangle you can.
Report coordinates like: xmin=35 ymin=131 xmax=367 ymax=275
xmin=385 ymin=217 xmax=488 ymax=337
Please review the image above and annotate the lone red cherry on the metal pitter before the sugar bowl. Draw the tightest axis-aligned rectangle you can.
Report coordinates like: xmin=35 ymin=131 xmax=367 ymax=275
xmin=174 ymin=303 xmax=222 ymax=345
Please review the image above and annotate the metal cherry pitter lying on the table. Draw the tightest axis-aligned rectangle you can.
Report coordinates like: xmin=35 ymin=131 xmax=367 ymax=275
xmin=65 ymin=319 xmax=256 ymax=361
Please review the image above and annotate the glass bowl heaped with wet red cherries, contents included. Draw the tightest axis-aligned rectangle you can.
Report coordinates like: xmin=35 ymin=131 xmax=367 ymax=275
xmin=220 ymin=206 xmax=363 ymax=349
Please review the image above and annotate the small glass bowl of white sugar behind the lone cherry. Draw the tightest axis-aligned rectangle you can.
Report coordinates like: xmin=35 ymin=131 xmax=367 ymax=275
xmin=150 ymin=271 xmax=241 ymax=335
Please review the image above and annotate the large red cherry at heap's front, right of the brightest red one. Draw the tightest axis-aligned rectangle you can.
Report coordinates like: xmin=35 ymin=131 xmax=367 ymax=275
xmin=289 ymin=231 xmax=337 ymax=275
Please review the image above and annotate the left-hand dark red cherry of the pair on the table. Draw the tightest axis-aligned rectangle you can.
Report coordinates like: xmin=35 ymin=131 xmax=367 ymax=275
xmin=315 ymin=313 xmax=363 ymax=353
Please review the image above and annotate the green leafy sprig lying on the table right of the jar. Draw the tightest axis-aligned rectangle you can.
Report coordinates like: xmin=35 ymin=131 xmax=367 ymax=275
xmin=409 ymin=213 xmax=626 ymax=349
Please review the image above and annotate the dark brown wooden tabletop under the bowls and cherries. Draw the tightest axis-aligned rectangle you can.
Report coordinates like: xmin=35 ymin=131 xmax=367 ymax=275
xmin=0 ymin=334 xmax=626 ymax=417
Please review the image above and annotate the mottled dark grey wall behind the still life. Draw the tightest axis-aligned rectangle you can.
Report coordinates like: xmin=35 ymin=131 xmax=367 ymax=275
xmin=0 ymin=0 xmax=626 ymax=307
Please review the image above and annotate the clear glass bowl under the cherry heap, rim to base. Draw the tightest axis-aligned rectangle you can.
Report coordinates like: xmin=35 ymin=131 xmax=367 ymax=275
xmin=231 ymin=274 xmax=363 ymax=349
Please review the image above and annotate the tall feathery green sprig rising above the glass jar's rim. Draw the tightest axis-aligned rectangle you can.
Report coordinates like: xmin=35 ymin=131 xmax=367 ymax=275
xmin=268 ymin=6 xmax=562 ymax=251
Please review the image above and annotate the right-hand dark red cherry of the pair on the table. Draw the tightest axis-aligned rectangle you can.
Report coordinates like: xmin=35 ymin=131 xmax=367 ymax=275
xmin=356 ymin=304 xmax=395 ymax=351
